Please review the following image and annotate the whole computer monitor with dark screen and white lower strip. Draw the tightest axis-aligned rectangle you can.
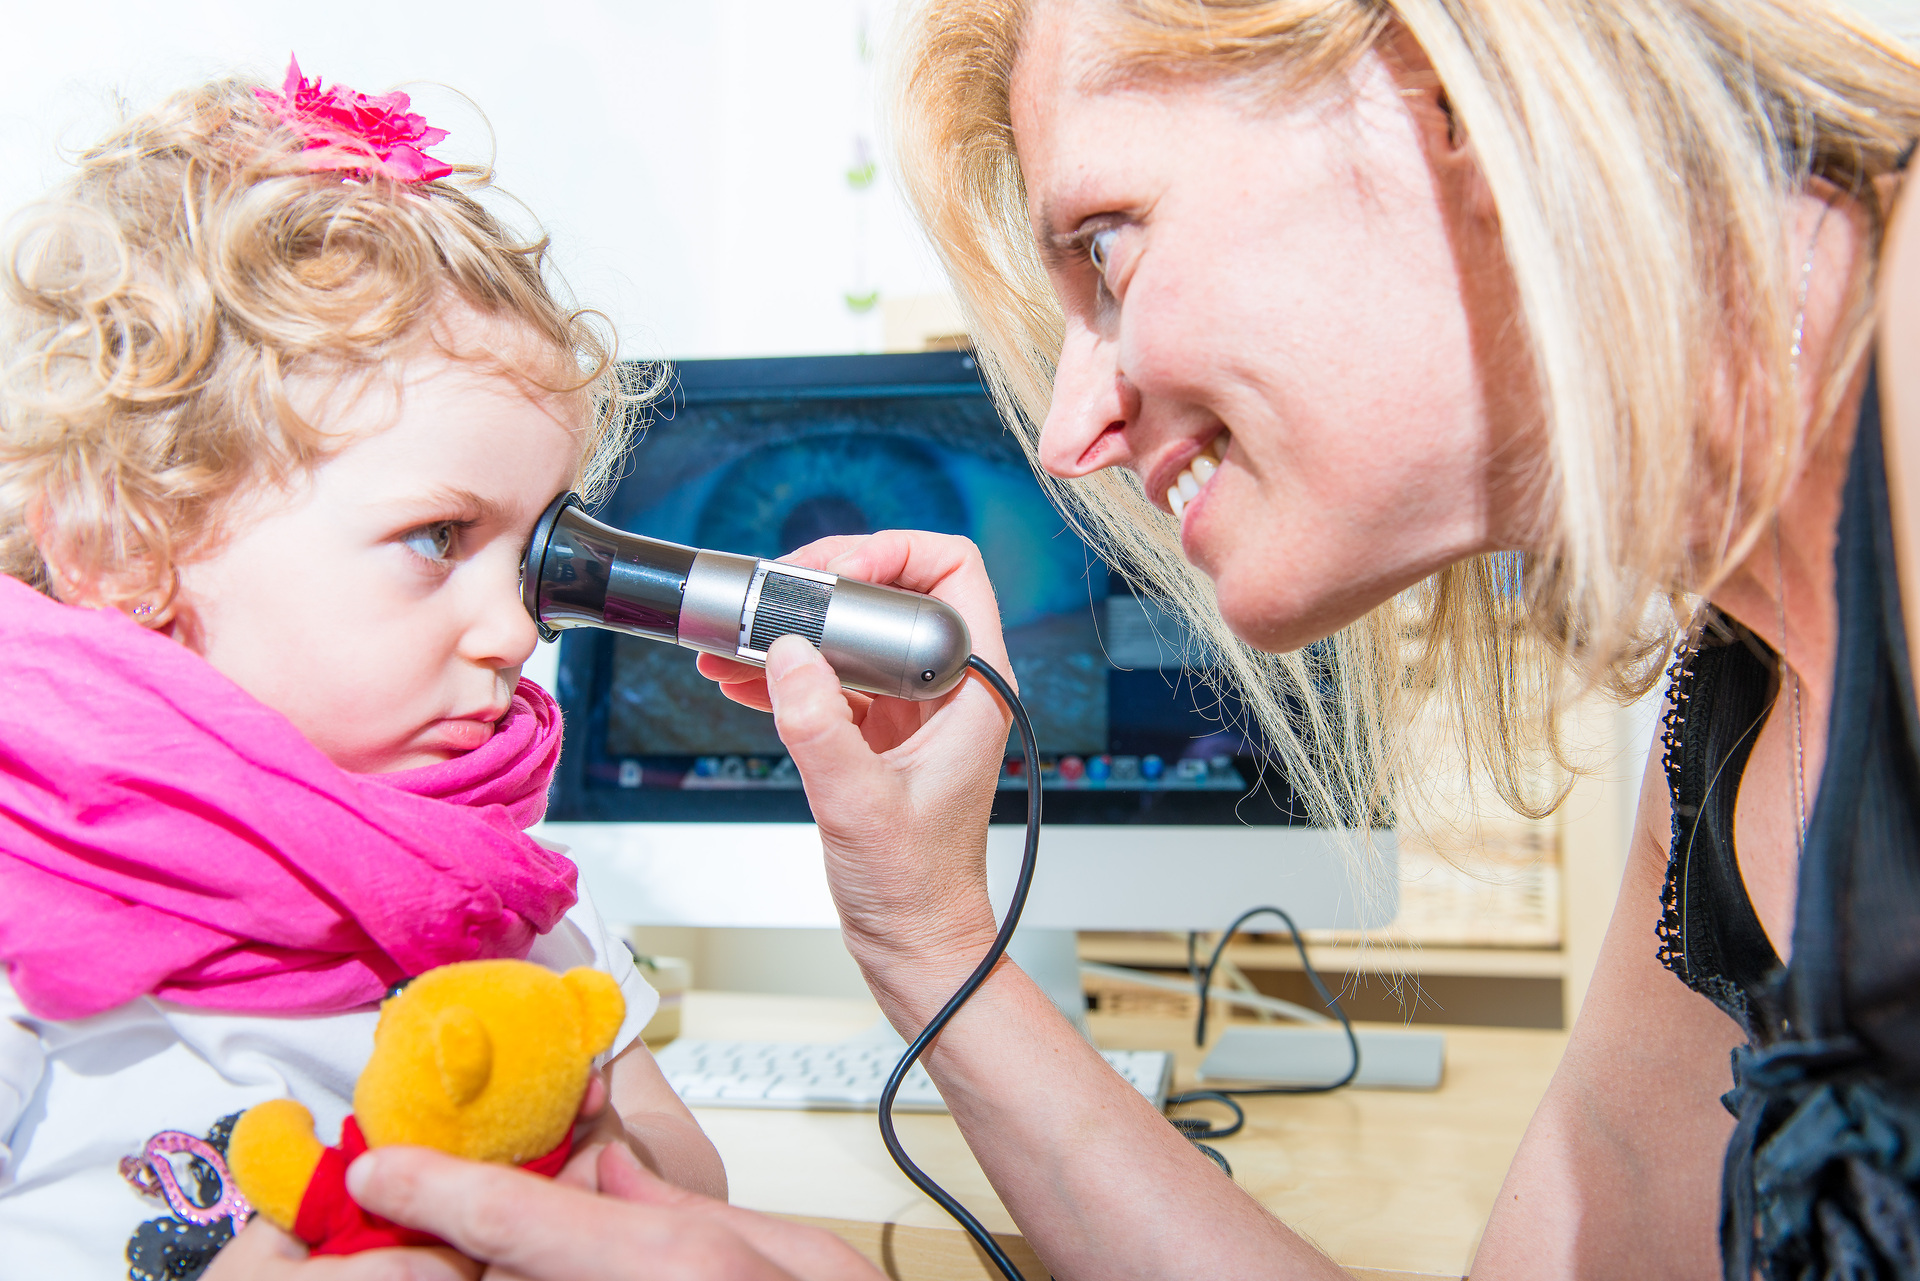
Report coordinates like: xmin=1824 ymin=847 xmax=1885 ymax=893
xmin=545 ymin=351 xmax=1394 ymax=948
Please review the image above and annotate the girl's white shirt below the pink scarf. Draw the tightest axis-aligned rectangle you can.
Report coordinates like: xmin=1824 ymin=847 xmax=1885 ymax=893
xmin=0 ymin=893 xmax=659 ymax=1281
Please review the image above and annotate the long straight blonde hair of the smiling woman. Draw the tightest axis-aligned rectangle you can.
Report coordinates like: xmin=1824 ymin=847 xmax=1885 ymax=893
xmin=893 ymin=0 xmax=1920 ymax=837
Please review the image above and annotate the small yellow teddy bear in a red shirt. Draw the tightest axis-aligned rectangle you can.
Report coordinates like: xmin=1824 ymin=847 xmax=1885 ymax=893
xmin=227 ymin=960 xmax=626 ymax=1254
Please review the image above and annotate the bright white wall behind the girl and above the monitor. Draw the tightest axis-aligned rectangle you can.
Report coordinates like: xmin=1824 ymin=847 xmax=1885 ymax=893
xmin=0 ymin=0 xmax=941 ymax=357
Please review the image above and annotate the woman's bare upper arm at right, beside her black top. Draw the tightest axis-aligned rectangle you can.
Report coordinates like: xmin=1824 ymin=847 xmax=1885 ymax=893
xmin=1473 ymin=743 xmax=1745 ymax=1281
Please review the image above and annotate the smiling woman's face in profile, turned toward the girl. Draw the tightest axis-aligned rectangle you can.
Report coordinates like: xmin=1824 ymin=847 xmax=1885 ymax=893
xmin=1012 ymin=4 xmax=1540 ymax=651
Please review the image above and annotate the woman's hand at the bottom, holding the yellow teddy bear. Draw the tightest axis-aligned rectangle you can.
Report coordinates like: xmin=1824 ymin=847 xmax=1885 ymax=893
xmin=349 ymin=1143 xmax=879 ymax=1281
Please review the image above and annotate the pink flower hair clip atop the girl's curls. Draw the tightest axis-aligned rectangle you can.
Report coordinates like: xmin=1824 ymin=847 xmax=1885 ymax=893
xmin=253 ymin=58 xmax=453 ymax=182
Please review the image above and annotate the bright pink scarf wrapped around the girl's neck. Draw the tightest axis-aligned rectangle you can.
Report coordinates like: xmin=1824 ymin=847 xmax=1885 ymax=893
xmin=0 ymin=574 xmax=576 ymax=1018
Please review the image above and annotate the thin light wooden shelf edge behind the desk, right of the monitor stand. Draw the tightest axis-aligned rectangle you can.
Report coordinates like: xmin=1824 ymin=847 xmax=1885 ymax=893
xmin=1079 ymin=933 xmax=1567 ymax=979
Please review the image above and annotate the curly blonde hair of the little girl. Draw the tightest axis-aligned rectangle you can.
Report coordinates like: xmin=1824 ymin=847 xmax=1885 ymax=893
xmin=0 ymin=81 xmax=636 ymax=622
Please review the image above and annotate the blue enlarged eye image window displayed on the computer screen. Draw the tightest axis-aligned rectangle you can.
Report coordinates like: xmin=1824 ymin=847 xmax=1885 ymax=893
xmin=603 ymin=398 xmax=1108 ymax=759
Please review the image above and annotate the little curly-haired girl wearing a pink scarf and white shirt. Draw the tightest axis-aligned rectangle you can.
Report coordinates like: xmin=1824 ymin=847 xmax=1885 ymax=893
xmin=0 ymin=57 xmax=724 ymax=1281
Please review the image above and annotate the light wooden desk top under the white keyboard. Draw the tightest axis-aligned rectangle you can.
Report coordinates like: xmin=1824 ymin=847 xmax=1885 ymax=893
xmin=684 ymin=993 xmax=1567 ymax=1281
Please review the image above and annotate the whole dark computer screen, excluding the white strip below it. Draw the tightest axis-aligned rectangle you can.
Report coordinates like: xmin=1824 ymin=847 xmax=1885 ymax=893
xmin=555 ymin=357 xmax=1292 ymax=822
